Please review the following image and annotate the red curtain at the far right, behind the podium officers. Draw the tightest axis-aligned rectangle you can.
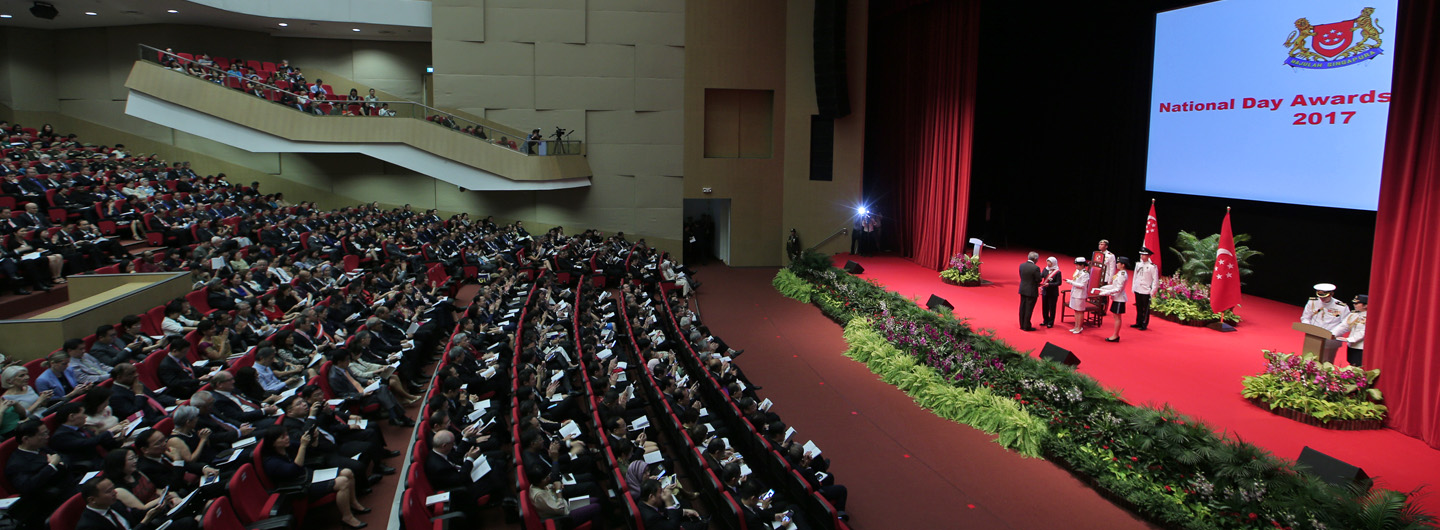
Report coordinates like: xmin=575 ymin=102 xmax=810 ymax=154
xmin=1365 ymin=0 xmax=1440 ymax=448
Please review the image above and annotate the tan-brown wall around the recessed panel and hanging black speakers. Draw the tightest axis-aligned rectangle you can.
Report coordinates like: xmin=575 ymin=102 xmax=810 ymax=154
xmin=684 ymin=0 xmax=868 ymax=266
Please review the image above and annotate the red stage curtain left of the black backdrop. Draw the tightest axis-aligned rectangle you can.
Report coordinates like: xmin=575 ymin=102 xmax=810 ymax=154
xmin=865 ymin=0 xmax=981 ymax=269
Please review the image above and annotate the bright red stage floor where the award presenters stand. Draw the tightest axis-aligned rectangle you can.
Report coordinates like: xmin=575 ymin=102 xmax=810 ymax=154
xmin=816 ymin=248 xmax=1440 ymax=513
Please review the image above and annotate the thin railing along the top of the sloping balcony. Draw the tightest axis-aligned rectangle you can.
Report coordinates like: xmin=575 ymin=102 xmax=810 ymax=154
xmin=140 ymin=45 xmax=583 ymax=157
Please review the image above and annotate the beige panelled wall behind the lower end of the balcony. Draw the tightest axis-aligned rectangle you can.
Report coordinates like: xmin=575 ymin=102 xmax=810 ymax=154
xmin=431 ymin=0 xmax=685 ymax=242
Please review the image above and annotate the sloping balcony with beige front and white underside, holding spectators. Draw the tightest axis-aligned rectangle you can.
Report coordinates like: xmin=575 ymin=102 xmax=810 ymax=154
xmin=125 ymin=46 xmax=592 ymax=190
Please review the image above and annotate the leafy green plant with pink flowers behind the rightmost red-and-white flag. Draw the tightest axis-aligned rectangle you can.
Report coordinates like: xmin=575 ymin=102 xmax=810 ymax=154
xmin=1151 ymin=230 xmax=1263 ymax=325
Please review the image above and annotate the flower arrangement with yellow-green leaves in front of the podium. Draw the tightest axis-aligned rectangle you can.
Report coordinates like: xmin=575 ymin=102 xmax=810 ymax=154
xmin=1240 ymin=350 xmax=1387 ymax=429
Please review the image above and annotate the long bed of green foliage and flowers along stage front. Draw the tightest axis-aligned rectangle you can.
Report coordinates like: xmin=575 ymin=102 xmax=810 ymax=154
xmin=771 ymin=250 xmax=1436 ymax=530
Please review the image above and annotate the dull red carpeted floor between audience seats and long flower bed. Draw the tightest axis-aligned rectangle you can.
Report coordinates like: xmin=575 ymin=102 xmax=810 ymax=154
xmin=698 ymin=265 xmax=1149 ymax=530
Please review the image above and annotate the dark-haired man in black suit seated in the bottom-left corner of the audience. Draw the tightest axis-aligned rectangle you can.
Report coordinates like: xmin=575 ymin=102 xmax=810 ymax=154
xmin=4 ymin=419 xmax=76 ymax=529
